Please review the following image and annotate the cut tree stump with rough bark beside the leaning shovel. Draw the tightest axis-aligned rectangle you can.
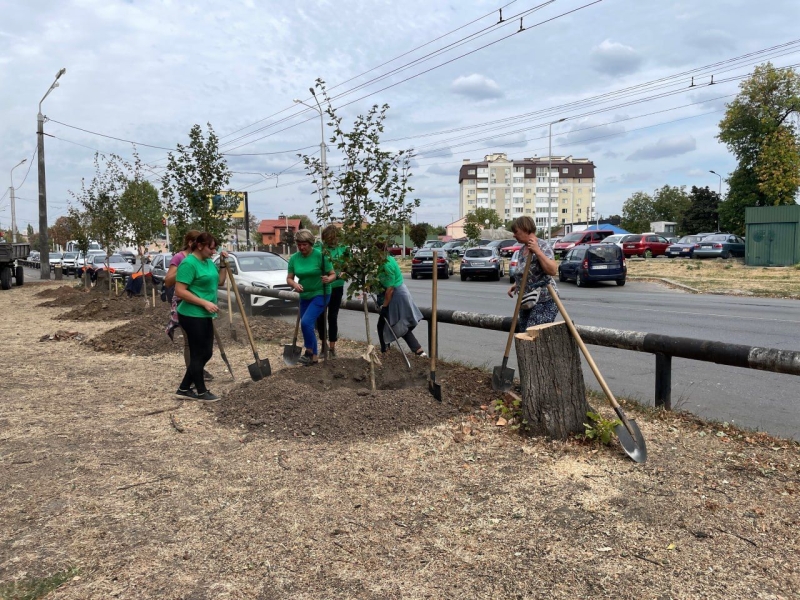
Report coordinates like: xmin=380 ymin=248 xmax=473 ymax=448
xmin=514 ymin=323 xmax=591 ymax=440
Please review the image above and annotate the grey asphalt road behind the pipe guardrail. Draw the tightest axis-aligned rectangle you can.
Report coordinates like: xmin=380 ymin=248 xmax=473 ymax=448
xmin=20 ymin=269 xmax=800 ymax=439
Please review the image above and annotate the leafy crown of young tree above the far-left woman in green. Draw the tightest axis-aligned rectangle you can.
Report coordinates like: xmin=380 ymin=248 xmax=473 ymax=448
xmin=161 ymin=123 xmax=240 ymax=240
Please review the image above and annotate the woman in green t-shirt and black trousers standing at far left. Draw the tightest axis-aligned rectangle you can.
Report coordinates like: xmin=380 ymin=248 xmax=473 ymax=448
xmin=175 ymin=232 xmax=228 ymax=402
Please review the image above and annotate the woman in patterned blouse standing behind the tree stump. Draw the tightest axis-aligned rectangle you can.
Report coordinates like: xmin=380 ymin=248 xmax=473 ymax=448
xmin=508 ymin=216 xmax=558 ymax=331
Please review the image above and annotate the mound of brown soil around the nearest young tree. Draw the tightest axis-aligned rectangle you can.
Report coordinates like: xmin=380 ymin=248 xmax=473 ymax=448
xmin=210 ymin=352 xmax=497 ymax=441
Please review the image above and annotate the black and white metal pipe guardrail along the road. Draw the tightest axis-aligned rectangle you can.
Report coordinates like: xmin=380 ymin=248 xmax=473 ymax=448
xmin=234 ymin=285 xmax=800 ymax=410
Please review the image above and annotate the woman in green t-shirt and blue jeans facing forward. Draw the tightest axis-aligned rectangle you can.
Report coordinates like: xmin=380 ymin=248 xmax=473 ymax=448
xmin=286 ymin=229 xmax=336 ymax=366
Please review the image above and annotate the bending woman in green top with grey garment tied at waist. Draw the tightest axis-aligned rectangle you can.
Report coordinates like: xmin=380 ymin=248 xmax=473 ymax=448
xmin=378 ymin=254 xmax=427 ymax=358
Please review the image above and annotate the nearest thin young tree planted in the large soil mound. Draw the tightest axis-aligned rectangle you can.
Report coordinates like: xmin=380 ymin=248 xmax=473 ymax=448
xmin=300 ymin=79 xmax=419 ymax=390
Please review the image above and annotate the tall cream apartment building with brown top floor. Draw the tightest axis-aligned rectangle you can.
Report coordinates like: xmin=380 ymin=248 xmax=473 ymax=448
xmin=458 ymin=152 xmax=596 ymax=227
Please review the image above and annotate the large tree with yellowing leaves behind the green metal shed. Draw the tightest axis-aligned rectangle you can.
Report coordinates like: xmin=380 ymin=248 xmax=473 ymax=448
xmin=717 ymin=63 xmax=800 ymax=234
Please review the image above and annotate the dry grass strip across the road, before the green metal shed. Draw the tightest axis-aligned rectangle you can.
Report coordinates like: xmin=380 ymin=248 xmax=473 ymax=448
xmin=628 ymin=258 xmax=800 ymax=299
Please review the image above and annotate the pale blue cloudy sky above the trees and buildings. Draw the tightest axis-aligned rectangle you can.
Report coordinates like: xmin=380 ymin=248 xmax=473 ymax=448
xmin=0 ymin=0 xmax=800 ymax=231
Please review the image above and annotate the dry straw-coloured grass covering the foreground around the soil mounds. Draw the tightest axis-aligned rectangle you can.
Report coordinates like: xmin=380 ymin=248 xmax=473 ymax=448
xmin=0 ymin=286 xmax=800 ymax=600
